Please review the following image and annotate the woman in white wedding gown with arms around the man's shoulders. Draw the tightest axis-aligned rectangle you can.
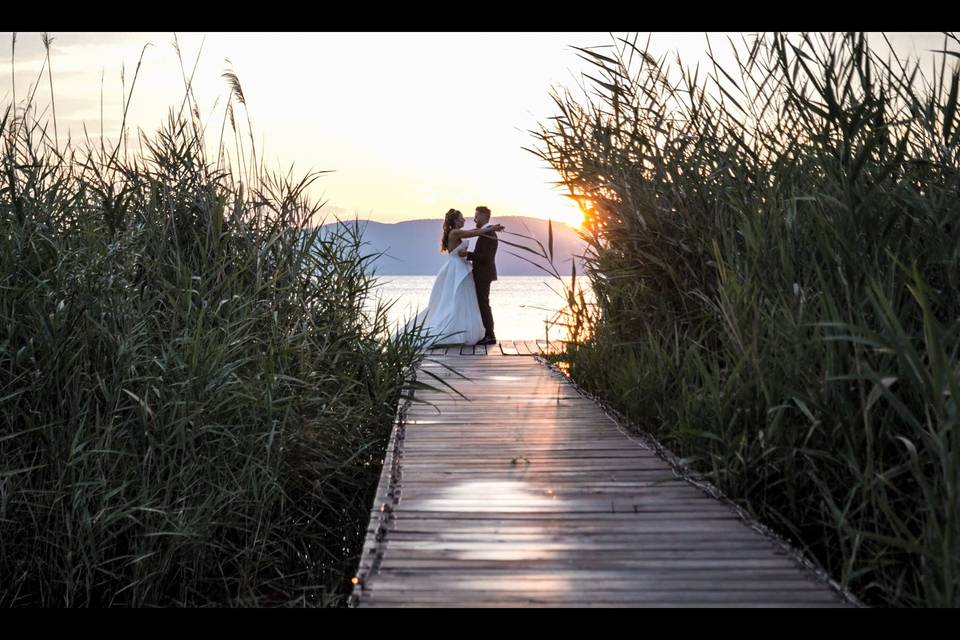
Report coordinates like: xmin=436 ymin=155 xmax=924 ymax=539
xmin=408 ymin=209 xmax=504 ymax=345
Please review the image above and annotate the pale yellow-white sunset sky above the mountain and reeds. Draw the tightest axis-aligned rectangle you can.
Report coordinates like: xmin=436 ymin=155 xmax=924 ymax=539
xmin=0 ymin=32 xmax=943 ymax=229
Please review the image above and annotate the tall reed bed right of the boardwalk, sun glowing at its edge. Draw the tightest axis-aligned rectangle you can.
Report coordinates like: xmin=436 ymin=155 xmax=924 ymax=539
xmin=533 ymin=33 xmax=960 ymax=607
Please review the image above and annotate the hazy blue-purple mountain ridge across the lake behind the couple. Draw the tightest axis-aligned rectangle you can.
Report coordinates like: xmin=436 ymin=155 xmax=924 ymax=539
xmin=324 ymin=216 xmax=584 ymax=276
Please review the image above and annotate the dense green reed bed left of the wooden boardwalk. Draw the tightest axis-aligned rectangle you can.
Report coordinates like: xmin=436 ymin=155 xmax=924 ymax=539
xmin=0 ymin=40 xmax=428 ymax=607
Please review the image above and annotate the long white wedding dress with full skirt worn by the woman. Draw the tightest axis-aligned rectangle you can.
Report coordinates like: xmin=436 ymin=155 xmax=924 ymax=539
xmin=408 ymin=240 xmax=485 ymax=345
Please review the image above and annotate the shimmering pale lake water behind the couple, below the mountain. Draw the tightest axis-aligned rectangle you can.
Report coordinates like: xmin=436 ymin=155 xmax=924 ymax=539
xmin=375 ymin=276 xmax=586 ymax=340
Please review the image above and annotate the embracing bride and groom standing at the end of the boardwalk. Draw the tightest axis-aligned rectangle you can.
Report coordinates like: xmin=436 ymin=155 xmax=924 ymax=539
xmin=412 ymin=206 xmax=504 ymax=345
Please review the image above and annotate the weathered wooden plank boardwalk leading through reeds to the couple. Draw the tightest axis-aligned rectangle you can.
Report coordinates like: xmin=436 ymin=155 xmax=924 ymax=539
xmin=351 ymin=350 xmax=847 ymax=607
